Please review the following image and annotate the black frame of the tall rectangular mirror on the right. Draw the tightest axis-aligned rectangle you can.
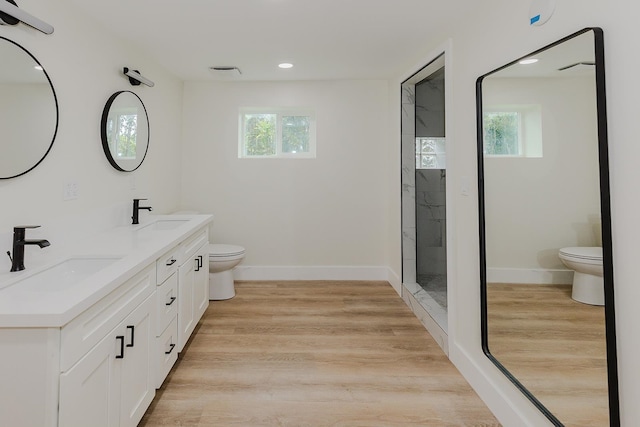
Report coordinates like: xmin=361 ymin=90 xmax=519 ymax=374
xmin=476 ymin=27 xmax=620 ymax=427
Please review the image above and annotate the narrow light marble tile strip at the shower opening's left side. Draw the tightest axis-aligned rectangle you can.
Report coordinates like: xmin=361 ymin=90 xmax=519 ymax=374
xmin=401 ymin=84 xmax=417 ymax=283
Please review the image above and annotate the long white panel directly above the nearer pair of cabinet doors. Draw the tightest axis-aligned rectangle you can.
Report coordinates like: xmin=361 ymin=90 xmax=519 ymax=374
xmin=60 ymin=264 xmax=156 ymax=372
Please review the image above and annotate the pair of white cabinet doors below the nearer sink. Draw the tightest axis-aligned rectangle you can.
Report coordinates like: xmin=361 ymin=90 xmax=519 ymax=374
xmin=58 ymin=294 xmax=155 ymax=427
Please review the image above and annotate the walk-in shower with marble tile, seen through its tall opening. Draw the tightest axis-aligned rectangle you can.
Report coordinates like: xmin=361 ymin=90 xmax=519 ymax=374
xmin=402 ymin=55 xmax=447 ymax=333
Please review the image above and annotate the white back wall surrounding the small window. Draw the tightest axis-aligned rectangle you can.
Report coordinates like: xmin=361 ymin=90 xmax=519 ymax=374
xmin=182 ymin=81 xmax=393 ymax=267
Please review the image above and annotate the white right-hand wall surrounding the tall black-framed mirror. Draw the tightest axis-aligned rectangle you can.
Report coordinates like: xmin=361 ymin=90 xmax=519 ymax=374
xmin=391 ymin=0 xmax=640 ymax=426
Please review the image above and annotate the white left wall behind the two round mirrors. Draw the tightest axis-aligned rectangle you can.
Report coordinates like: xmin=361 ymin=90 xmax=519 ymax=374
xmin=0 ymin=0 xmax=182 ymax=271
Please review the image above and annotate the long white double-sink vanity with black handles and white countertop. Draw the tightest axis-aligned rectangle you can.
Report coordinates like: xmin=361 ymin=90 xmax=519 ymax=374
xmin=0 ymin=215 xmax=213 ymax=427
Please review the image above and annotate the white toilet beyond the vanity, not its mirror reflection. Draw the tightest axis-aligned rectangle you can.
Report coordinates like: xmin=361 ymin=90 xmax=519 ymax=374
xmin=209 ymin=244 xmax=244 ymax=300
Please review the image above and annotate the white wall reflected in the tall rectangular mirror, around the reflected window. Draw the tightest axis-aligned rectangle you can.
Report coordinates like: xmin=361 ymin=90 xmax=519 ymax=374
xmin=482 ymin=77 xmax=601 ymax=269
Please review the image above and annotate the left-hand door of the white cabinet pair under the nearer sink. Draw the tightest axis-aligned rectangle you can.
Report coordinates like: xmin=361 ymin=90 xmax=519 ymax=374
xmin=58 ymin=324 xmax=125 ymax=427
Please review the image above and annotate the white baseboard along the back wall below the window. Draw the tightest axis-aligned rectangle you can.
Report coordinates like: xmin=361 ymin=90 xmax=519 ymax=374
xmin=233 ymin=265 xmax=392 ymax=284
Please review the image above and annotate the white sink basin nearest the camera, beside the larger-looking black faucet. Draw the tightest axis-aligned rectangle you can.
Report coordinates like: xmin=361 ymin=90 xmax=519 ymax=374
xmin=14 ymin=257 xmax=120 ymax=292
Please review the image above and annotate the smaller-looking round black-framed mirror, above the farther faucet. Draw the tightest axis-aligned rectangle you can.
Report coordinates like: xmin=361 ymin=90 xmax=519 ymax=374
xmin=100 ymin=91 xmax=149 ymax=172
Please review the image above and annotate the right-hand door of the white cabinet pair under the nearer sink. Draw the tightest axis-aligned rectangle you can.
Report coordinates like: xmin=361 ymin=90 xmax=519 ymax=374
xmin=120 ymin=296 xmax=156 ymax=427
